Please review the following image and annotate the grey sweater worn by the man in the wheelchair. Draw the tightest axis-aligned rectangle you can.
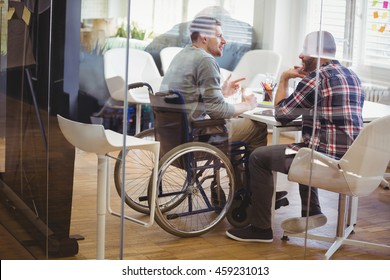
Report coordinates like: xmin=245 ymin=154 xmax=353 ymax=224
xmin=160 ymin=46 xmax=234 ymax=121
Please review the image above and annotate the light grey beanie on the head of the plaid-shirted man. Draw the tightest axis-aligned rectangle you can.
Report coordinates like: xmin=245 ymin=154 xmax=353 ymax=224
xmin=303 ymin=31 xmax=336 ymax=59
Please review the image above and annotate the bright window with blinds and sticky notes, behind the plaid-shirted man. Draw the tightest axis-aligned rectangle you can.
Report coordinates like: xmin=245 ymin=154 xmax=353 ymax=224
xmin=307 ymin=0 xmax=390 ymax=83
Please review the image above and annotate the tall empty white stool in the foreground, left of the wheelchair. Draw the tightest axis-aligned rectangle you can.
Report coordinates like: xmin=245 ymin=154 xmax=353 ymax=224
xmin=57 ymin=115 xmax=160 ymax=259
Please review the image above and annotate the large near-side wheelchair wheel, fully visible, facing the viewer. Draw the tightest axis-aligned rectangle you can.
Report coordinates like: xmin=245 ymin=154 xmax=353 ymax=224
xmin=149 ymin=142 xmax=234 ymax=237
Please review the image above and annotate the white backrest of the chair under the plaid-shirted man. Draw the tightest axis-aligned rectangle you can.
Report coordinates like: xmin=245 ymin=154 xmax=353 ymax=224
xmin=339 ymin=115 xmax=390 ymax=196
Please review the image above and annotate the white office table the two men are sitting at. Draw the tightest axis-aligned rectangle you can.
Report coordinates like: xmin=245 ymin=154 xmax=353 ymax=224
xmin=241 ymin=101 xmax=390 ymax=228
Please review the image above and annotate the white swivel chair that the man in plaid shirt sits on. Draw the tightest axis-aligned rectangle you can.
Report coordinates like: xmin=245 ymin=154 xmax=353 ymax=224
xmin=285 ymin=115 xmax=390 ymax=259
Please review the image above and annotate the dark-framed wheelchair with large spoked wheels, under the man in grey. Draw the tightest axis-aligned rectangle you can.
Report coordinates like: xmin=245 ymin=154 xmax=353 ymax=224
xmin=114 ymin=83 xmax=288 ymax=237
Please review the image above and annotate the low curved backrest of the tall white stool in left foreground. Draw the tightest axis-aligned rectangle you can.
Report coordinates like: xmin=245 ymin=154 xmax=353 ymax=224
xmin=57 ymin=115 xmax=108 ymax=154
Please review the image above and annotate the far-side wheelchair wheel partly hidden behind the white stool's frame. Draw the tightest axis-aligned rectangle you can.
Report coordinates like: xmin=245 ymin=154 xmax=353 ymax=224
xmin=114 ymin=128 xmax=154 ymax=214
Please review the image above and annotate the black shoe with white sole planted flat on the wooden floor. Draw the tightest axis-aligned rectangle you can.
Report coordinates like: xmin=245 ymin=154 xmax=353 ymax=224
xmin=226 ymin=225 xmax=273 ymax=243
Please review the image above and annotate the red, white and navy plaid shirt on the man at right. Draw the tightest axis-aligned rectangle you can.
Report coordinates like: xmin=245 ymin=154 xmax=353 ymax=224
xmin=275 ymin=60 xmax=364 ymax=158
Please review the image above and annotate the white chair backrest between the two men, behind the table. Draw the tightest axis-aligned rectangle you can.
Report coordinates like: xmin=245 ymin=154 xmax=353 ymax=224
xmin=232 ymin=50 xmax=282 ymax=87
